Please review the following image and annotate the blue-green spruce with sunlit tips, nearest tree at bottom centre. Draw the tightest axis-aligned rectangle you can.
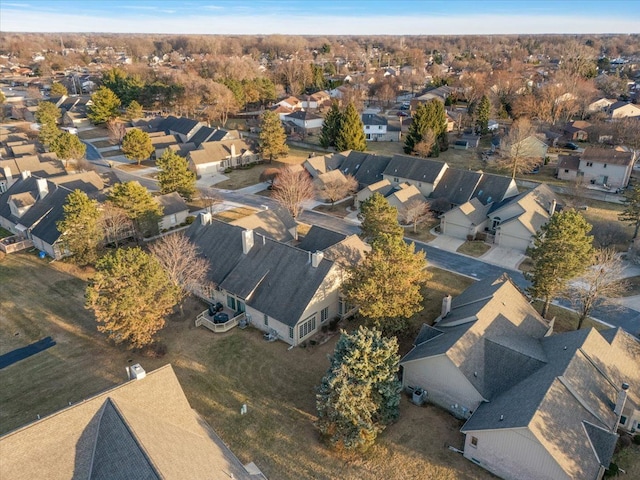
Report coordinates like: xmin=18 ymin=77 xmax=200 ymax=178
xmin=316 ymin=327 xmax=402 ymax=451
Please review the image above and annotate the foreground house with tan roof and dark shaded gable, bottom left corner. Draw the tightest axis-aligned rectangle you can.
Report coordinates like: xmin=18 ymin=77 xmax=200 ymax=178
xmin=0 ymin=364 xmax=266 ymax=480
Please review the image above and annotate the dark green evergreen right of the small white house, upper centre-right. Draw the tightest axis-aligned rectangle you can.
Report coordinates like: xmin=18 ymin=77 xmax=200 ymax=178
xmin=404 ymin=99 xmax=447 ymax=156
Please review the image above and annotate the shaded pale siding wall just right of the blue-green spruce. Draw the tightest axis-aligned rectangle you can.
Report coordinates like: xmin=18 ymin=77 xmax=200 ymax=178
xmin=402 ymin=355 xmax=483 ymax=417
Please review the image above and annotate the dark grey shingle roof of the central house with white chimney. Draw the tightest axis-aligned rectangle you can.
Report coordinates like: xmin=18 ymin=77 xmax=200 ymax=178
xmin=187 ymin=218 xmax=333 ymax=326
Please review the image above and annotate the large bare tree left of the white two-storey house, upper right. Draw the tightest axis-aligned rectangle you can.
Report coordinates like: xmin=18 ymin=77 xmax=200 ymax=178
xmin=498 ymin=118 xmax=543 ymax=178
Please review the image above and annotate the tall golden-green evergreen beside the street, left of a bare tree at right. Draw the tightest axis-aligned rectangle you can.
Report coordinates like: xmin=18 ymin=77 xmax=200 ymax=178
xmin=527 ymin=209 xmax=593 ymax=317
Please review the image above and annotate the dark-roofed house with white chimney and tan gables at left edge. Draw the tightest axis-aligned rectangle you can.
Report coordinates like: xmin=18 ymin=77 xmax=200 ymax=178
xmin=0 ymin=171 xmax=105 ymax=259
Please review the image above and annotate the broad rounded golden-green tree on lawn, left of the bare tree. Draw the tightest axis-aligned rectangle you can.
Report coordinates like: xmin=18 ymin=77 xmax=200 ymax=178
xmin=86 ymin=247 xmax=176 ymax=348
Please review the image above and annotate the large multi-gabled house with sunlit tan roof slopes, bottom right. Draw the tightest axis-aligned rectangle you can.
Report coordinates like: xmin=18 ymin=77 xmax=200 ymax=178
xmin=400 ymin=274 xmax=640 ymax=480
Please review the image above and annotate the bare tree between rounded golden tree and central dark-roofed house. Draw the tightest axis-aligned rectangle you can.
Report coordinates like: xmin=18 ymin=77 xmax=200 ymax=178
xmin=149 ymin=233 xmax=209 ymax=313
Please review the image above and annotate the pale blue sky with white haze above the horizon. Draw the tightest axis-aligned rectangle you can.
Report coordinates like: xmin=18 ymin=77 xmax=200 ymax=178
xmin=0 ymin=0 xmax=640 ymax=35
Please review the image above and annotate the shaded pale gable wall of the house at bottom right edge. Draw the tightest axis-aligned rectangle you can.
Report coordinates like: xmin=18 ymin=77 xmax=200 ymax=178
xmin=464 ymin=428 xmax=572 ymax=480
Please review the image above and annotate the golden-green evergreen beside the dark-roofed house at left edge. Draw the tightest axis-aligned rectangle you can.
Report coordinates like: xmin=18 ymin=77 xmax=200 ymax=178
xmin=56 ymin=190 xmax=103 ymax=265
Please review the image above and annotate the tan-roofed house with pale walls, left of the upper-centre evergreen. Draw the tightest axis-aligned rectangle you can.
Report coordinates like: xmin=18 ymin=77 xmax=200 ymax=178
xmin=187 ymin=140 xmax=260 ymax=175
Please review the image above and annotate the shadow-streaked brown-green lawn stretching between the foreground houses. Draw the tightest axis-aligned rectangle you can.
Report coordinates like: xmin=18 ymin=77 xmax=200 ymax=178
xmin=0 ymin=254 xmax=493 ymax=480
